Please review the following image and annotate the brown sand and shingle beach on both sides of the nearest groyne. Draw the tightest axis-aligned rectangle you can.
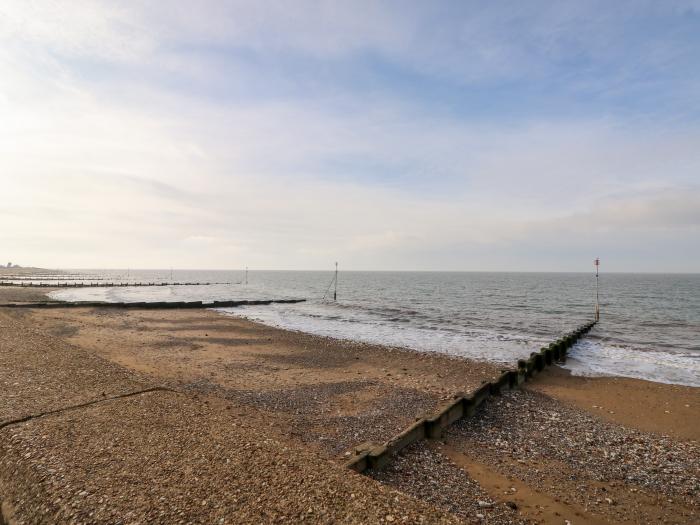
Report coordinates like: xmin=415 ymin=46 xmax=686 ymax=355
xmin=0 ymin=288 xmax=700 ymax=524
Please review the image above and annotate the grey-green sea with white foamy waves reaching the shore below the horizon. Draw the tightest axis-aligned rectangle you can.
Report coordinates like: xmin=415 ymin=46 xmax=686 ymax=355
xmin=46 ymin=270 xmax=700 ymax=386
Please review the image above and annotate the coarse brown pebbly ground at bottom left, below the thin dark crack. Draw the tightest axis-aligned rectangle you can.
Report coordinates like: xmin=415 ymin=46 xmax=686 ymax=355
xmin=0 ymin=392 xmax=459 ymax=524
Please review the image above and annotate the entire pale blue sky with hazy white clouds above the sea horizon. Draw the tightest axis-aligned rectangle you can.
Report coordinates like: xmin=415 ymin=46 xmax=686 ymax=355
xmin=0 ymin=0 xmax=700 ymax=272
